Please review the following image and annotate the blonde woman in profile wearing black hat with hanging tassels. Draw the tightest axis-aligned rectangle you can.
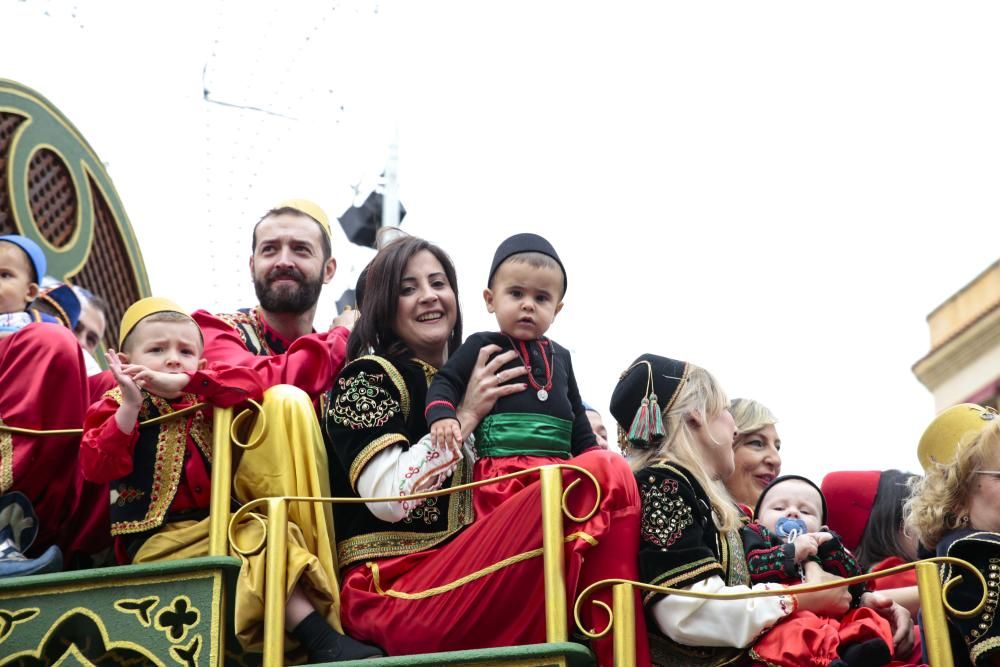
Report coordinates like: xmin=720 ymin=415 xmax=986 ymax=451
xmin=611 ymin=354 xmax=913 ymax=665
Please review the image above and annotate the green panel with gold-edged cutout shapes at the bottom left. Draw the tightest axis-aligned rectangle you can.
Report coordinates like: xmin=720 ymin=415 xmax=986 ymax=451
xmin=0 ymin=558 xmax=239 ymax=667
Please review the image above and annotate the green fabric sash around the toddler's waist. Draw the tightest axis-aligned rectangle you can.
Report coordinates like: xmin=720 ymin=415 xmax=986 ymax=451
xmin=476 ymin=412 xmax=573 ymax=459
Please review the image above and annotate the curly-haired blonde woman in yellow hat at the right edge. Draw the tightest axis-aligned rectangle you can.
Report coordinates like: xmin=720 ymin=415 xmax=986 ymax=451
xmin=906 ymin=404 xmax=1000 ymax=665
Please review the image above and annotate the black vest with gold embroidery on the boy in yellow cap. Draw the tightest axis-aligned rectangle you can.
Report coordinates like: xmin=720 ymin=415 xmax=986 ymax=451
xmin=108 ymin=389 xmax=212 ymax=535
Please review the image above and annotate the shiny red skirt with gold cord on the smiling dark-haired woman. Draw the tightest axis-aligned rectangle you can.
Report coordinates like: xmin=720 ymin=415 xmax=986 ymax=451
xmin=341 ymin=450 xmax=649 ymax=665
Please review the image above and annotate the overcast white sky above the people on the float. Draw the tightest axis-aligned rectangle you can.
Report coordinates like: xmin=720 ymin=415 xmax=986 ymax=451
xmin=0 ymin=0 xmax=1000 ymax=479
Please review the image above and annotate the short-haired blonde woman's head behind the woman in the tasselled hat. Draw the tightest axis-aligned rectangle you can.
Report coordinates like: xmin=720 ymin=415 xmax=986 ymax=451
xmin=725 ymin=398 xmax=781 ymax=508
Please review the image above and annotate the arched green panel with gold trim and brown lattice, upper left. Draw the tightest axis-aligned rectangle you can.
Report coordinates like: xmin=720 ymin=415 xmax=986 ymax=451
xmin=0 ymin=79 xmax=150 ymax=341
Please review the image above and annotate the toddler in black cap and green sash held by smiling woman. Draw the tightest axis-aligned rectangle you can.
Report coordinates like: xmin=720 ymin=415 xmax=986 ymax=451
xmin=425 ymin=234 xmax=597 ymax=513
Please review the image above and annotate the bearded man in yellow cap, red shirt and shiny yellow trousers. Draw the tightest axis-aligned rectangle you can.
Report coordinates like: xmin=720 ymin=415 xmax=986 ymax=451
xmin=184 ymin=199 xmax=381 ymax=662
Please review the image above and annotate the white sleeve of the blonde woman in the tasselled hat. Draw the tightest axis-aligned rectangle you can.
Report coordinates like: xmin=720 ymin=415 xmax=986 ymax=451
xmin=653 ymin=576 xmax=795 ymax=648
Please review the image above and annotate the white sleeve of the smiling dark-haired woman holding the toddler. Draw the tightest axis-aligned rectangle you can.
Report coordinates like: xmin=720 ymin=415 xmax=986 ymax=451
xmin=357 ymin=434 xmax=473 ymax=523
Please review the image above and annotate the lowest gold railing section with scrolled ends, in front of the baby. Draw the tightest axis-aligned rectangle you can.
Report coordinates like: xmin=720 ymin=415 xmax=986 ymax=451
xmin=573 ymin=556 xmax=987 ymax=667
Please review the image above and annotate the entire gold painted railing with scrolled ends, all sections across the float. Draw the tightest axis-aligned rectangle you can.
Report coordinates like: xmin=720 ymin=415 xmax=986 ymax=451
xmin=0 ymin=401 xmax=986 ymax=667
